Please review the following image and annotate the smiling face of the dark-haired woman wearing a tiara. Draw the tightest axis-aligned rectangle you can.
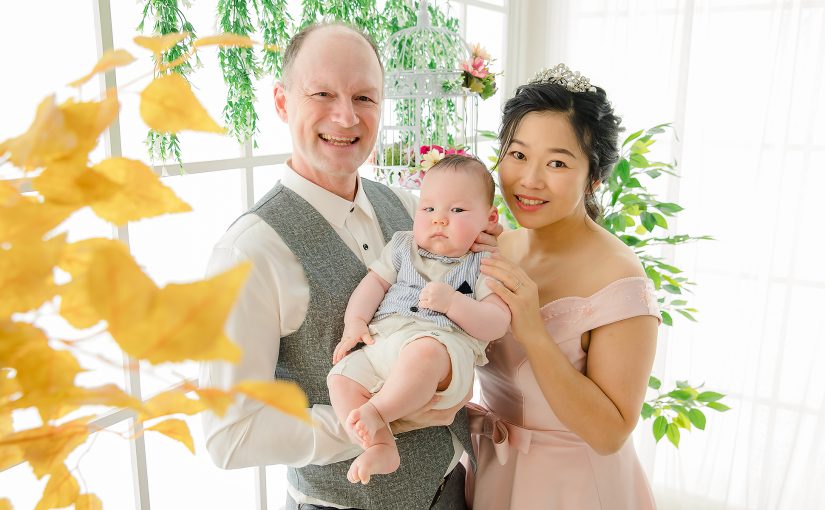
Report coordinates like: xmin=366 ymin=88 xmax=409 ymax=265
xmin=499 ymin=112 xmax=588 ymax=229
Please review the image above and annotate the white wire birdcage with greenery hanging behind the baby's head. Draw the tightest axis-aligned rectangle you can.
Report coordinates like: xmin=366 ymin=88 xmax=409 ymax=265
xmin=375 ymin=0 xmax=478 ymax=188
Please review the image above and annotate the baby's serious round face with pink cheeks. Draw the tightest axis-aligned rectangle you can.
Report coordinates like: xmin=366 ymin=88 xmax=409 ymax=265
xmin=413 ymin=170 xmax=497 ymax=257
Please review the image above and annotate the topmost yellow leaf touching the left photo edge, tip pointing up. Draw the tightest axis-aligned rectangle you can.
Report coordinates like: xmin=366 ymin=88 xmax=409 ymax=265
xmin=2 ymin=95 xmax=77 ymax=170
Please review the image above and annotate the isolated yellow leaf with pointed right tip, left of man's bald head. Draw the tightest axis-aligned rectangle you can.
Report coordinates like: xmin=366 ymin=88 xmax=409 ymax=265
xmin=140 ymin=73 xmax=224 ymax=133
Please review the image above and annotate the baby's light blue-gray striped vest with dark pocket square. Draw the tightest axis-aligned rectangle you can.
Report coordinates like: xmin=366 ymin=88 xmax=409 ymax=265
xmin=372 ymin=232 xmax=486 ymax=331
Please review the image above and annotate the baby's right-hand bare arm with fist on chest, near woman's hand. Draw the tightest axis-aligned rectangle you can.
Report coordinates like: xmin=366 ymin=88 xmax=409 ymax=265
xmin=418 ymin=282 xmax=510 ymax=342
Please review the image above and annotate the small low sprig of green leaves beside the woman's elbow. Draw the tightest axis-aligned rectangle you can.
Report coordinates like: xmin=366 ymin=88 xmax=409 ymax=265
xmin=642 ymin=376 xmax=730 ymax=448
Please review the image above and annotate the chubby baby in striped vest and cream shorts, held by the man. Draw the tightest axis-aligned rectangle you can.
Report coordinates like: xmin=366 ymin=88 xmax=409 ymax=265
xmin=327 ymin=155 xmax=510 ymax=483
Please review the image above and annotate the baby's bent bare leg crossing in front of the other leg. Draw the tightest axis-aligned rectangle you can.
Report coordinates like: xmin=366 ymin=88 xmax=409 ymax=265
xmin=346 ymin=336 xmax=451 ymax=445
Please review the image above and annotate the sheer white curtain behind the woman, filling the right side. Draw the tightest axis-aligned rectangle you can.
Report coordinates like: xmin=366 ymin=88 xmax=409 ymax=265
xmin=508 ymin=0 xmax=825 ymax=510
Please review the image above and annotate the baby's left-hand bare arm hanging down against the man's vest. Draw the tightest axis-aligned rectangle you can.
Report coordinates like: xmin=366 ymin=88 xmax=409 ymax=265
xmin=332 ymin=271 xmax=390 ymax=364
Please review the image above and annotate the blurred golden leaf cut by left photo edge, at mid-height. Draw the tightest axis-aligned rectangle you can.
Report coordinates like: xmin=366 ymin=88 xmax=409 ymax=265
xmin=0 ymin=234 xmax=66 ymax=319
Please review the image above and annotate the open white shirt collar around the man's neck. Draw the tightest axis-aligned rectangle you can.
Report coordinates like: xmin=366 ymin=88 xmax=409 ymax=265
xmin=281 ymin=160 xmax=375 ymax=228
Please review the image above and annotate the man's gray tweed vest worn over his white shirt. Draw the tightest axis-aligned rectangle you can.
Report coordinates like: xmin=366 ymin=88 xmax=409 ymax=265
xmin=247 ymin=178 xmax=475 ymax=510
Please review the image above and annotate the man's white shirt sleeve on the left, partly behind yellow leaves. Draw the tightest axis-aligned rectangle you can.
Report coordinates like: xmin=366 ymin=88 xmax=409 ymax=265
xmin=200 ymin=224 xmax=362 ymax=469
